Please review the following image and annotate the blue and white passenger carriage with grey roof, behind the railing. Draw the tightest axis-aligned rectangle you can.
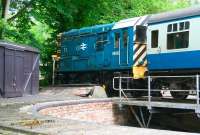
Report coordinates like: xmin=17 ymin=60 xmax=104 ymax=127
xmin=147 ymin=8 xmax=200 ymax=98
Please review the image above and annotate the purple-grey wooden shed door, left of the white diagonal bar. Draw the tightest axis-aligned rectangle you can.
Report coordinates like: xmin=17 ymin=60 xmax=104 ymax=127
xmin=4 ymin=49 xmax=23 ymax=97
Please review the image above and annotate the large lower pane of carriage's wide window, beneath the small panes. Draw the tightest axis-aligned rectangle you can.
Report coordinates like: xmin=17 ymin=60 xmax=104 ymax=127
xmin=167 ymin=31 xmax=189 ymax=49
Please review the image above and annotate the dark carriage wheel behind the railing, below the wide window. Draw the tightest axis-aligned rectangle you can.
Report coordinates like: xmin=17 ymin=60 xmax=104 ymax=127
xmin=170 ymin=83 xmax=189 ymax=99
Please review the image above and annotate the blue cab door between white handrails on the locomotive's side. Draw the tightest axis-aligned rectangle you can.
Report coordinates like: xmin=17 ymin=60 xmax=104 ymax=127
xmin=119 ymin=29 xmax=129 ymax=65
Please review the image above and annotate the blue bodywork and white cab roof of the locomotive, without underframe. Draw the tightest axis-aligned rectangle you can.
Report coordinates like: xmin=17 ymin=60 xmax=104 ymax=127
xmin=60 ymin=17 xmax=146 ymax=72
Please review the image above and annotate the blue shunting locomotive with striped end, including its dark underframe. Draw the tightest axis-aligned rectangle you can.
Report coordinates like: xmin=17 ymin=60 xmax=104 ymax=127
xmin=59 ymin=16 xmax=148 ymax=94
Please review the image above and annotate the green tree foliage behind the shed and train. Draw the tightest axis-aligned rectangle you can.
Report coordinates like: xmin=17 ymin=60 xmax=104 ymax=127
xmin=0 ymin=0 xmax=190 ymax=85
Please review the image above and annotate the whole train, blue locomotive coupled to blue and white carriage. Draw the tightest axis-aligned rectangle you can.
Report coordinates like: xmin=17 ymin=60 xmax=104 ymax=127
xmin=60 ymin=8 xmax=200 ymax=98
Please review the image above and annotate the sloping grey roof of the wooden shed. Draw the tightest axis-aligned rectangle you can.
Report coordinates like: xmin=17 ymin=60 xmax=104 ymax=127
xmin=0 ymin=40 xmax=39 ymax=53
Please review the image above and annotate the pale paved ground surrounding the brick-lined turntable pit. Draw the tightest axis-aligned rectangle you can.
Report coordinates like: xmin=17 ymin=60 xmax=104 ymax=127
xmin=0 ymin=87 xmax=199 ymax=135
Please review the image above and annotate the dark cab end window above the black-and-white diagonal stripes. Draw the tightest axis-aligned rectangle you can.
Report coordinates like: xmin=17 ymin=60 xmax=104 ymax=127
xmin=135 ymin=25 xmax=147 ymax=43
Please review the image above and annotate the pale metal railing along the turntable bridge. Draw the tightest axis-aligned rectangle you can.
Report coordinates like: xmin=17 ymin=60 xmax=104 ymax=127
xmin=113 ymin=74 xmax=200 ymax=114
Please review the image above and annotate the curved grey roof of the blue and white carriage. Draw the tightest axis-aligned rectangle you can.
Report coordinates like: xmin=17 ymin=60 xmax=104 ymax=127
xmin=148 ymin=7 xmax=200 ymax=24
